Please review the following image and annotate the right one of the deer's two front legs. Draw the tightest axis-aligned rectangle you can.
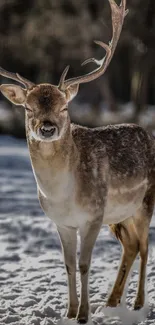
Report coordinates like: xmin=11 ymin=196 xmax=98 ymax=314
xmin=77 ymin=220 xmax=102 ymax=324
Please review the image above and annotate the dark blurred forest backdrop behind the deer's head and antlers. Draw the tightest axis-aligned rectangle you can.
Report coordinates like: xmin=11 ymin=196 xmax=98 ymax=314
xmin=0 ymin=0 xmax=155 ymax=136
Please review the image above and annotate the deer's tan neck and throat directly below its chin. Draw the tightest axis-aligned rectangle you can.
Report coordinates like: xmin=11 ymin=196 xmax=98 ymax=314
xmin=27 ymin=125 xmax=78 ymax=195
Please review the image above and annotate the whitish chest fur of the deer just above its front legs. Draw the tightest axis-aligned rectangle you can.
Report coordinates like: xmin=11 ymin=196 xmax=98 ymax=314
xmin=36 ymin=173 xmax=94 ymax=228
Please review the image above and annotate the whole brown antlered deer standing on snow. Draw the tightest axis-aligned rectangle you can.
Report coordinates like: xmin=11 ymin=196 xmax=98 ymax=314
xmin=0 ymin=0 xmax=155 ymax=324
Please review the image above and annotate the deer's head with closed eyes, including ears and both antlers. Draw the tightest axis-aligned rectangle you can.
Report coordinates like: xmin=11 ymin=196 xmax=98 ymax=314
xmin=0 ymin=0 xmax=127 ymax=141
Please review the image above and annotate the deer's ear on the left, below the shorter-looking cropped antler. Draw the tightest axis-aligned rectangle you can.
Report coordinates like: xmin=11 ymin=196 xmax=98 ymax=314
xmin=0 ymin=84 xmax=26 ymax=105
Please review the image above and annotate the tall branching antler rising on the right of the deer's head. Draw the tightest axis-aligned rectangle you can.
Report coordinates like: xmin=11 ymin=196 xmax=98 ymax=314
xmin=59 ymin=0 xmax=128 ymax=91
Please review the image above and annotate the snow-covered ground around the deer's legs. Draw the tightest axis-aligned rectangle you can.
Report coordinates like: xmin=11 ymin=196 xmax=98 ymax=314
xmin=0 ymin=136 xmax=155 ymax=325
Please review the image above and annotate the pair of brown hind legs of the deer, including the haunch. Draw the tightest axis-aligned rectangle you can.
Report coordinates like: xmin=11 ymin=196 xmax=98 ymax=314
xmin=107 ymin=189 xmax=155 ymax=309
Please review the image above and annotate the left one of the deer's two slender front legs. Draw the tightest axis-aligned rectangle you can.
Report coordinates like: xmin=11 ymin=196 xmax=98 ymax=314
xmin=57 ymin=227 xmax=78 ymax=318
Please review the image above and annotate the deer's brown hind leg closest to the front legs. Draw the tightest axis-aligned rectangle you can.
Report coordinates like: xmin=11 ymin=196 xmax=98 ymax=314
xmin=106 ymin=222 xmax=139 ymax=307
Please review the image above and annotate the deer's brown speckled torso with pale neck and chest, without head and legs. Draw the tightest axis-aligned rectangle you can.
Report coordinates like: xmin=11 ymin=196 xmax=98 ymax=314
xmin=28 ymin=125 xmax=154 ymax=228
